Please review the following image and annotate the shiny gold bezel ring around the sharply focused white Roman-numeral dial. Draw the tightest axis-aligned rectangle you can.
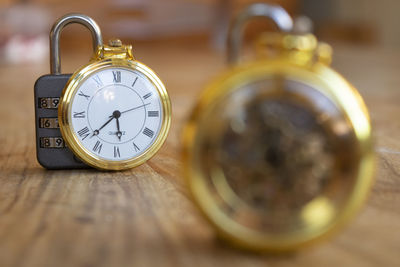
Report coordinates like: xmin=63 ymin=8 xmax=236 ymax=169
xmin=58 ymin=58 xmax=171 ymax=170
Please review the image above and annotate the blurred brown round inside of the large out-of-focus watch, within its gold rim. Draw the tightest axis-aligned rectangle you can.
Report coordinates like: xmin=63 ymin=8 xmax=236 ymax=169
xmin=191 ymin=77 xmax=359 ymax=240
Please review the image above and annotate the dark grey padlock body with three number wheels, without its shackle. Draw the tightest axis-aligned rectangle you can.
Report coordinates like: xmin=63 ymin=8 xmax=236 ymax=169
xmin=34 ymin=74 xmax=89 ymax=169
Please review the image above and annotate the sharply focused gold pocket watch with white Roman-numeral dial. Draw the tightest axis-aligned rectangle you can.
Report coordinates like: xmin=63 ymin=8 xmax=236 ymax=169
xmin=55 ymin=15 xmax=171 ymax=170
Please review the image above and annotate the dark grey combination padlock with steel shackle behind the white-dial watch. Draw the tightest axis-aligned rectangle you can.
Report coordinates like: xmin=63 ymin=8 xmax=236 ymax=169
xmin=34 ymin=14 xmax=103 ymax=169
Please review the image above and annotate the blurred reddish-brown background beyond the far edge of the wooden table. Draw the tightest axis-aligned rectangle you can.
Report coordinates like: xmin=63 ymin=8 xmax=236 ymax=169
xmin=0 ymin=0 xmax=400 ymax=64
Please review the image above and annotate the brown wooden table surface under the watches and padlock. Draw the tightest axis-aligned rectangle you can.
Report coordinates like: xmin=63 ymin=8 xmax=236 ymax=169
xmin=0 ymin=40 xmax=400 ymax=267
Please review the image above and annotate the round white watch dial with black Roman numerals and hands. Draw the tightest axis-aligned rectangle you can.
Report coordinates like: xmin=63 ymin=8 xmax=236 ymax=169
xmin=69 ymin=67 xmax=164 ymax=161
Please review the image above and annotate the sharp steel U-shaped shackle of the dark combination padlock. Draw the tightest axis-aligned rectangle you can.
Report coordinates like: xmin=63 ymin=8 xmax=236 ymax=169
xmin=50 ymin=13 xmax=103 ymax=75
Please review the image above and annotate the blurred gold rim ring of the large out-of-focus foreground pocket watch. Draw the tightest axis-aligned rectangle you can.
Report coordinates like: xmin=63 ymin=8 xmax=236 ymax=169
xmin=182 ymin=59 xmax=375 ymax=252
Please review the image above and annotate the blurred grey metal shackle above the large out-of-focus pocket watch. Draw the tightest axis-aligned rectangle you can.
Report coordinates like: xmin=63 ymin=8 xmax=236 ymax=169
xmin=227 ymin=3 xmax=293 ymax=64
